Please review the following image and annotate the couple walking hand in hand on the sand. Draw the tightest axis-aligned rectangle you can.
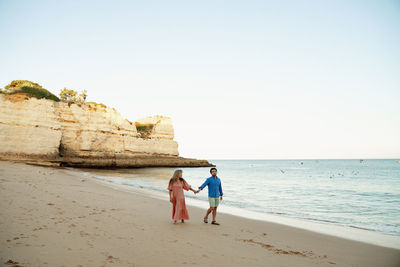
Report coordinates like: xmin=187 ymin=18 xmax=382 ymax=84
xmin=168 ymin=168 xmax=223 ymax=225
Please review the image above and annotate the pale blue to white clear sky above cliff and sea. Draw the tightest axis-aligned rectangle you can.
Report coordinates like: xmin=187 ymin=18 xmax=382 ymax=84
xmin=0 ymin=0 xmax=400 ymax=159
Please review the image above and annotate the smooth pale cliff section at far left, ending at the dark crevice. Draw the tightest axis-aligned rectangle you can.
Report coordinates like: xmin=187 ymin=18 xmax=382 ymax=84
xmin=0 ymin=94 xmax=62 ymax=159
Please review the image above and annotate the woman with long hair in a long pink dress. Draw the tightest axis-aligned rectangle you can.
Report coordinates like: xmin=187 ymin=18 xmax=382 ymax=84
xmin=168 ymin=170 xmax=197 ymax=223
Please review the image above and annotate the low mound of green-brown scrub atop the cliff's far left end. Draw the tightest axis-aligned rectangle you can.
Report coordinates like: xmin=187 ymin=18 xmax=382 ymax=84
xmin=1 ymin=80 xmax=60 ymax=101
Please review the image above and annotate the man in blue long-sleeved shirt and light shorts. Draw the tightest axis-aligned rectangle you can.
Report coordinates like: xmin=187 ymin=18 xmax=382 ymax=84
xmin=197 ymin=168 xmax=223 ymax=225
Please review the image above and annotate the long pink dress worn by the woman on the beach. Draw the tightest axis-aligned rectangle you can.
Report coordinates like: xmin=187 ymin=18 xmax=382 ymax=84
xmin=168 ymin=180 xmax=190 ymax=221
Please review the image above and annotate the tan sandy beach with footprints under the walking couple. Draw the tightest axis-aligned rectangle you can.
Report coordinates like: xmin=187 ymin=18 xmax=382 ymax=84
xmin=0 ymin=161 xmax=400 ymax=266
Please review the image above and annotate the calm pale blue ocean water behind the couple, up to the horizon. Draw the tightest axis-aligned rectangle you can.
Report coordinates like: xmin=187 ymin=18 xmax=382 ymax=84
xmin=77 ymin=159 xmax=400 ymax=248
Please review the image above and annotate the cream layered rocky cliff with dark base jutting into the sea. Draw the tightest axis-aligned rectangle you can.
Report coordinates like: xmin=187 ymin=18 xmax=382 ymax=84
xmin=0 ymin=94 xmax=212 ymax=167
